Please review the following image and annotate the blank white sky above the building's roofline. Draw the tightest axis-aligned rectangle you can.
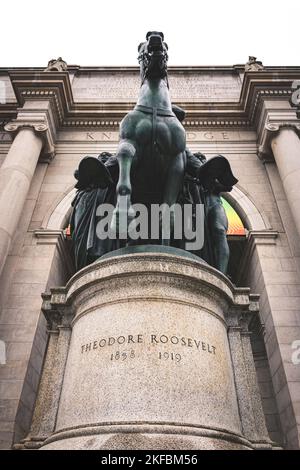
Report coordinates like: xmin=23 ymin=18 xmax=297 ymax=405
xmin=0 ymin=0 xmax=300 ymax=67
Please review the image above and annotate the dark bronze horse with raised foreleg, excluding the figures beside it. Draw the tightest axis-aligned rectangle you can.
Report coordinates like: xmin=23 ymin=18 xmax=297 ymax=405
xmin=112 ymin=31 xmax=186 ymax=244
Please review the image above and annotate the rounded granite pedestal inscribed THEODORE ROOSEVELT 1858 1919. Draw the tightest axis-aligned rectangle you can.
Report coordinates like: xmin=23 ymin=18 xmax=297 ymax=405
xmin=23 ymin=247 xmax=272 ymax=450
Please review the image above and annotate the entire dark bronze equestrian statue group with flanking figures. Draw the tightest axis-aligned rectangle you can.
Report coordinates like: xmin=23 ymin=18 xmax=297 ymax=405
xmin=70 ymin=31 xmax=237 ymax=273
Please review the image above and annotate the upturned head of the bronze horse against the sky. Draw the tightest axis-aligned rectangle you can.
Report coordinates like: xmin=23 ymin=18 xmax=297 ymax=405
xmin=138 ymin=31 xmax=168 ymax=83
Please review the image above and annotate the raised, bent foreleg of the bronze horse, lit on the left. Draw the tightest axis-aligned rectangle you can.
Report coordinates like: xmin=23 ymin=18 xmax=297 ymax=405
xmin=111 ymin=140 xmax=136 ymax=235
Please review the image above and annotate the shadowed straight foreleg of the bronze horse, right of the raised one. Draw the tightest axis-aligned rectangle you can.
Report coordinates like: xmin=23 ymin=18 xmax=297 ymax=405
xmin=161 ymin=152 xmax=185 ymax=246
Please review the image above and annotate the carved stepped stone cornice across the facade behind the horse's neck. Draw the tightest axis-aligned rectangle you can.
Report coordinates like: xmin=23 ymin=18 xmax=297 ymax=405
xmin=0 ymin=66 xmax=300 ymax=130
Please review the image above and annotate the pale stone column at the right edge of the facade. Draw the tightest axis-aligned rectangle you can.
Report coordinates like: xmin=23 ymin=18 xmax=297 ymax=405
xmin=271 ymin=127 xmax=300 ymax=241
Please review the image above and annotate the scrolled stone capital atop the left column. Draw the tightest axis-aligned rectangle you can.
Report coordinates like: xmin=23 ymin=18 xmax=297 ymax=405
xmin=4 ymin=120 xmax=55 ymax=163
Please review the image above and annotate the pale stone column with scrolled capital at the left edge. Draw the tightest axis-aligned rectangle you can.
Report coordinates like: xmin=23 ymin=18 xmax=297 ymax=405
xmin=0 ymin=124 xmax=47 ymax=273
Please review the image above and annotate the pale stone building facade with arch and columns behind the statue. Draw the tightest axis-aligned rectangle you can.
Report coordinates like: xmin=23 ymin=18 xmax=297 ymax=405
xmin=0 ymin=62 xmax=300 ymax=449
